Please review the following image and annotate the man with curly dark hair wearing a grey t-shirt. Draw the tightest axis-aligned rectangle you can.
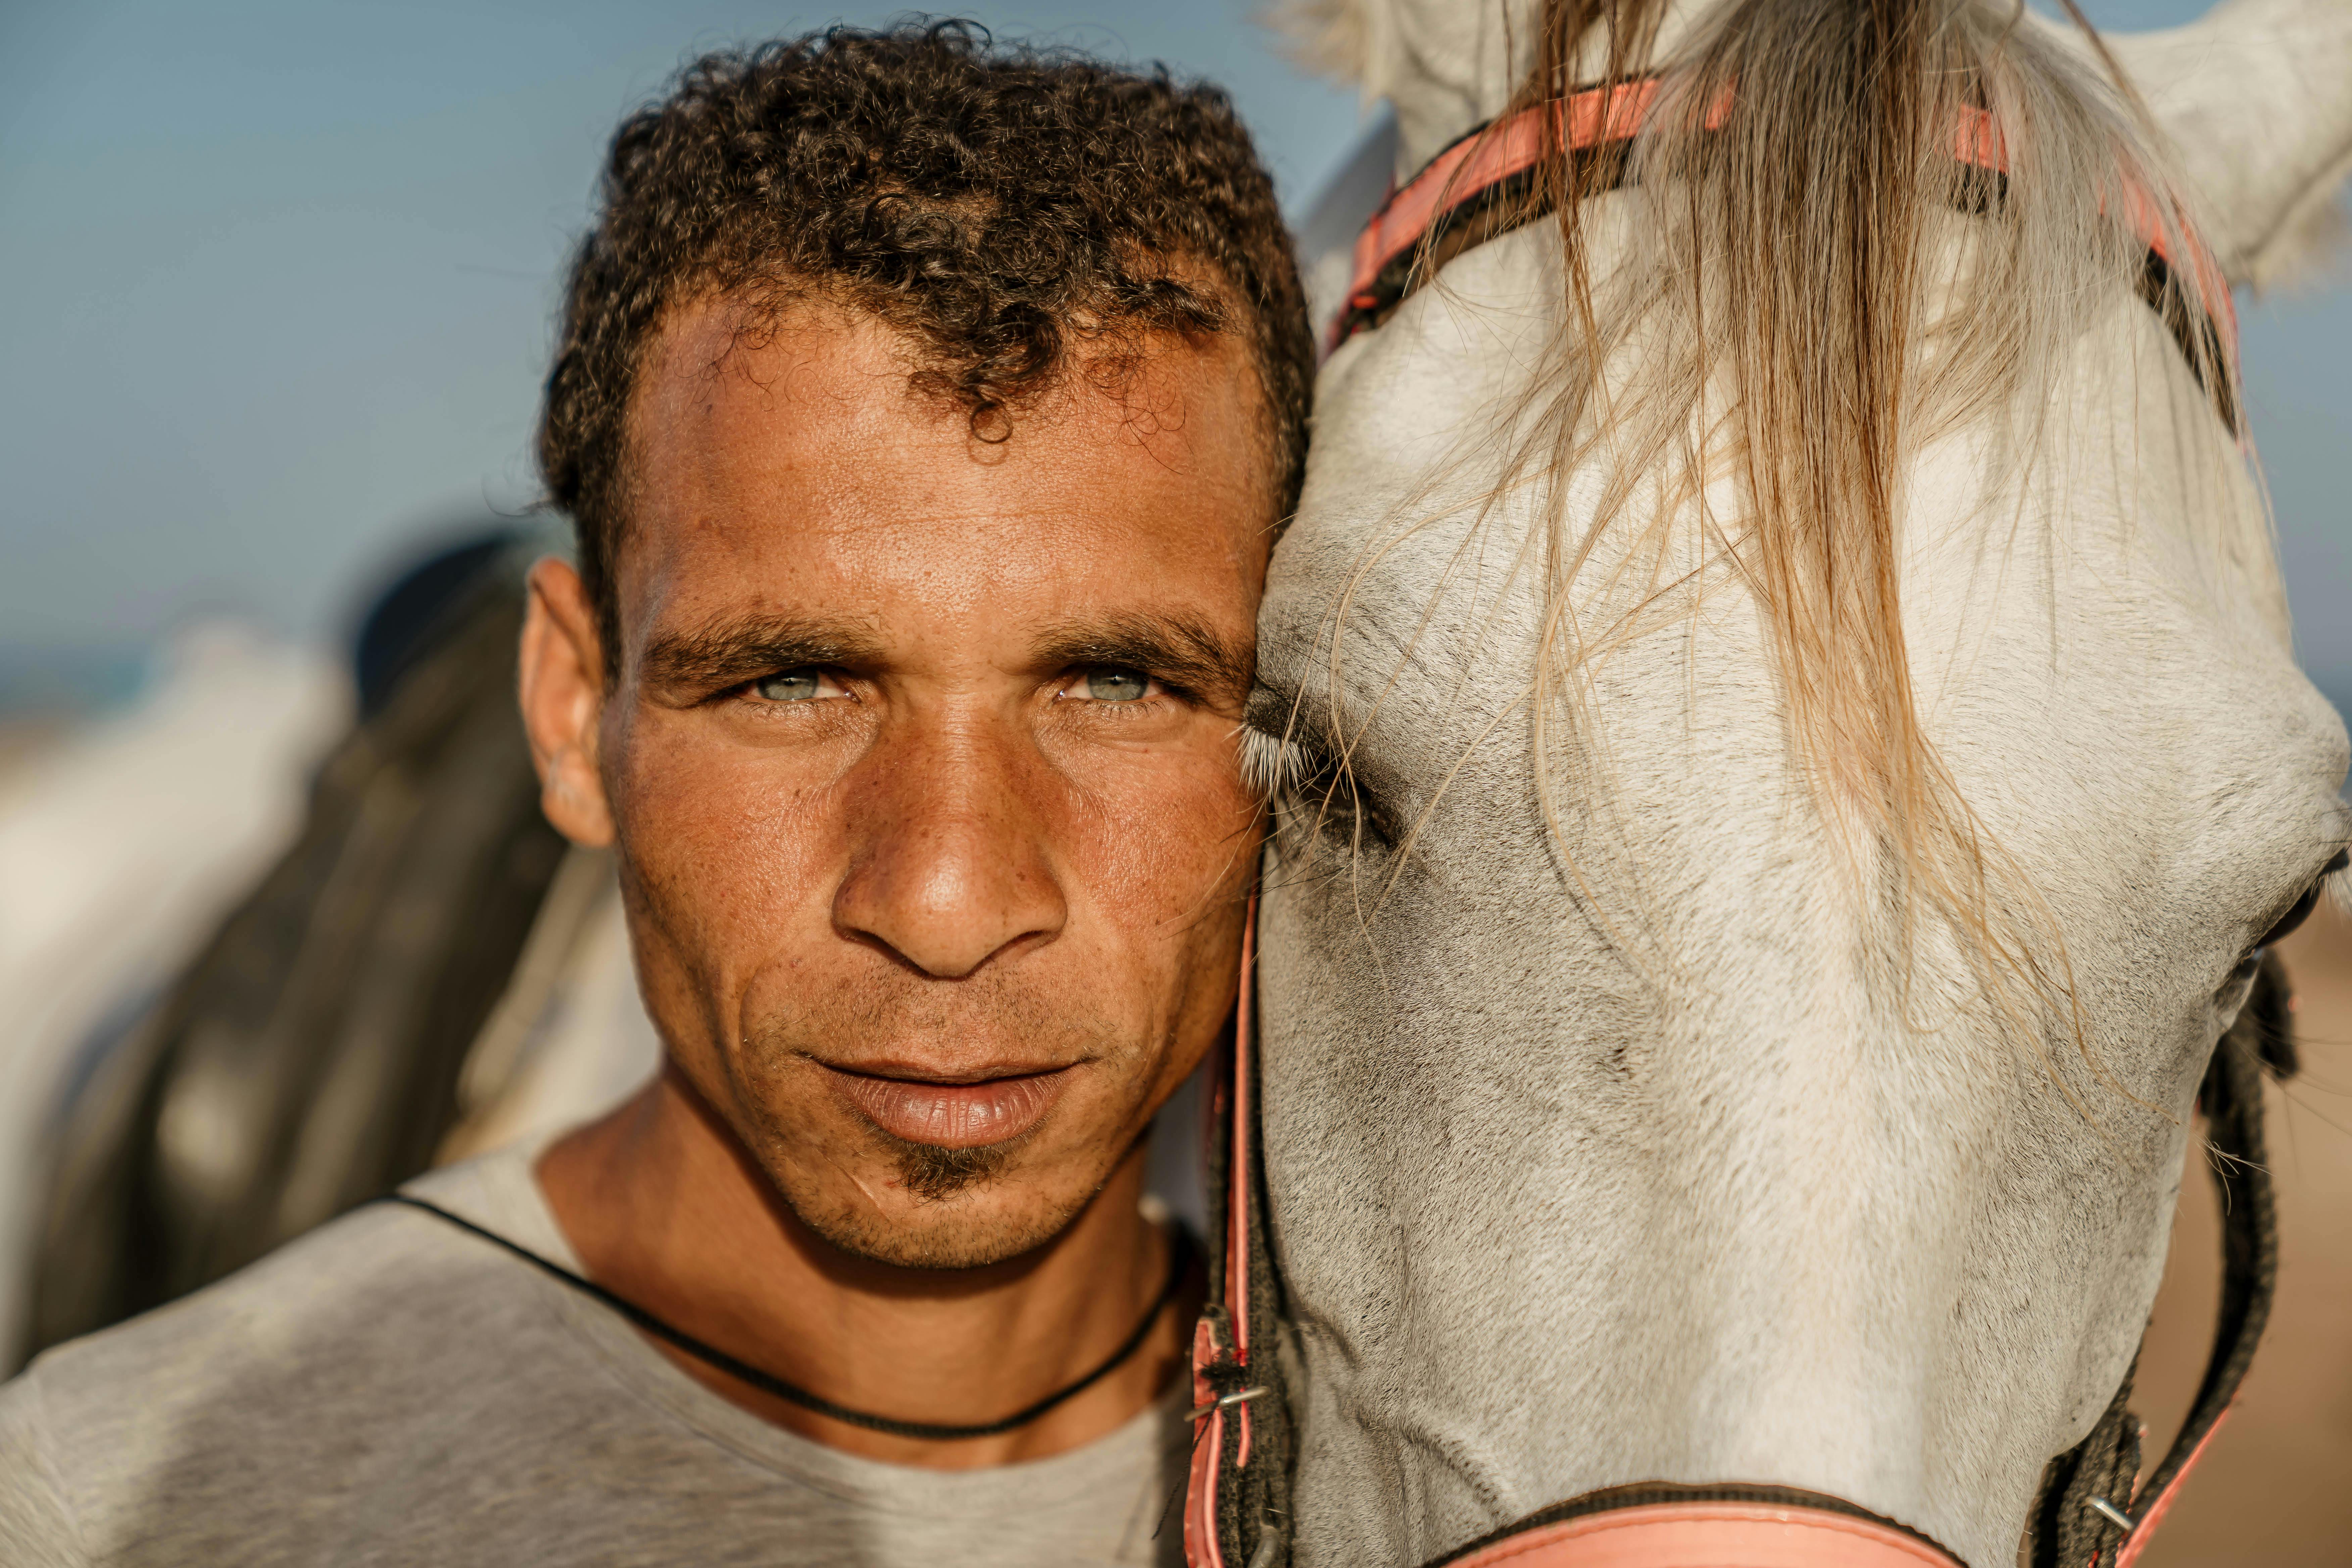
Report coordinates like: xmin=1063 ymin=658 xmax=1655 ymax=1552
xmin=0 ymin=26 xmax=1310 ymax=1568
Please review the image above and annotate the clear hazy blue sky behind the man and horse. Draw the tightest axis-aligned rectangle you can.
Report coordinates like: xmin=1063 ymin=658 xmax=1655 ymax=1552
xmin=0 ymin=0 xmax=2352 ymax=700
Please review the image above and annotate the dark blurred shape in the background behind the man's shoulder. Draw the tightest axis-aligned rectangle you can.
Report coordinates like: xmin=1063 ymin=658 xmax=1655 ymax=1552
xmin=26 ymin=536 xmax=565 ymax=1354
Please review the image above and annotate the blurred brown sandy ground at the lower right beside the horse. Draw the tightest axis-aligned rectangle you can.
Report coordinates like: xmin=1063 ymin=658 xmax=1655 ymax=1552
xmin=2136 ymin=905 xmax=2352 ymax=1568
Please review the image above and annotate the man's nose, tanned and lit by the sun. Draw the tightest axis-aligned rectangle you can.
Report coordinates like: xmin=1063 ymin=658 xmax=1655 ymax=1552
xmin=833 ymin=722 xmax=1070 ymax=980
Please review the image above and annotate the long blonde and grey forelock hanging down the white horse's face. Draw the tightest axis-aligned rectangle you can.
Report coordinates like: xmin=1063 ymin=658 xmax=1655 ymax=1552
xmin=1261 ymin=0 xmax=2274 ymax=1098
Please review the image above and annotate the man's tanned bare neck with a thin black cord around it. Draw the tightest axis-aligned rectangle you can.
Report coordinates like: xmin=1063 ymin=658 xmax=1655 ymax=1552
xmin=539 ymin=1067 xmax=1188 ymax=1469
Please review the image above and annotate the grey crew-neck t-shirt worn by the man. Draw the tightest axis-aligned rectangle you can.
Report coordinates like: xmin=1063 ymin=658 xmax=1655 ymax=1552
xmin=0 ymin=1152 xmax=1185 ymax=1568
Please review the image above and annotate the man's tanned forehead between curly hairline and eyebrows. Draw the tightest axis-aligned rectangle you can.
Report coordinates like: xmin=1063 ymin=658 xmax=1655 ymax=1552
xmin=616 ymin=301 xmax=1275 ymax=649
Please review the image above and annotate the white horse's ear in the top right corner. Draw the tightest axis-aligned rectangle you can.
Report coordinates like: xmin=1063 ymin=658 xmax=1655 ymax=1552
xmin=2105 ymin=0 xmax=2352 ymax=289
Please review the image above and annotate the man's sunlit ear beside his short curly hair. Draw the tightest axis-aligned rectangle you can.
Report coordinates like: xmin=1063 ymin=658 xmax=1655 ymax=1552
xmin=520 ymin=557 xmax=611 ymax=849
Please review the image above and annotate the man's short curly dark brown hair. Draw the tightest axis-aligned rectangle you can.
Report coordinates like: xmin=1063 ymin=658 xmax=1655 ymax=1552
xmin=539 ymin=21 xmax=1315 ymax=649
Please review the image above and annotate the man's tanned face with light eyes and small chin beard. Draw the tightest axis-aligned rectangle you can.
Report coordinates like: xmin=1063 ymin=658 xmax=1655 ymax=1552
xmin=550 ymin=303 xmax=1272 ymax=1267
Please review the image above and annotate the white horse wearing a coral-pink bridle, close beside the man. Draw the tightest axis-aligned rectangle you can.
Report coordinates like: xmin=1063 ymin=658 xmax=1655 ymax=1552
xmin=1244 ymin=0 xmax=2352 ymax=1568
